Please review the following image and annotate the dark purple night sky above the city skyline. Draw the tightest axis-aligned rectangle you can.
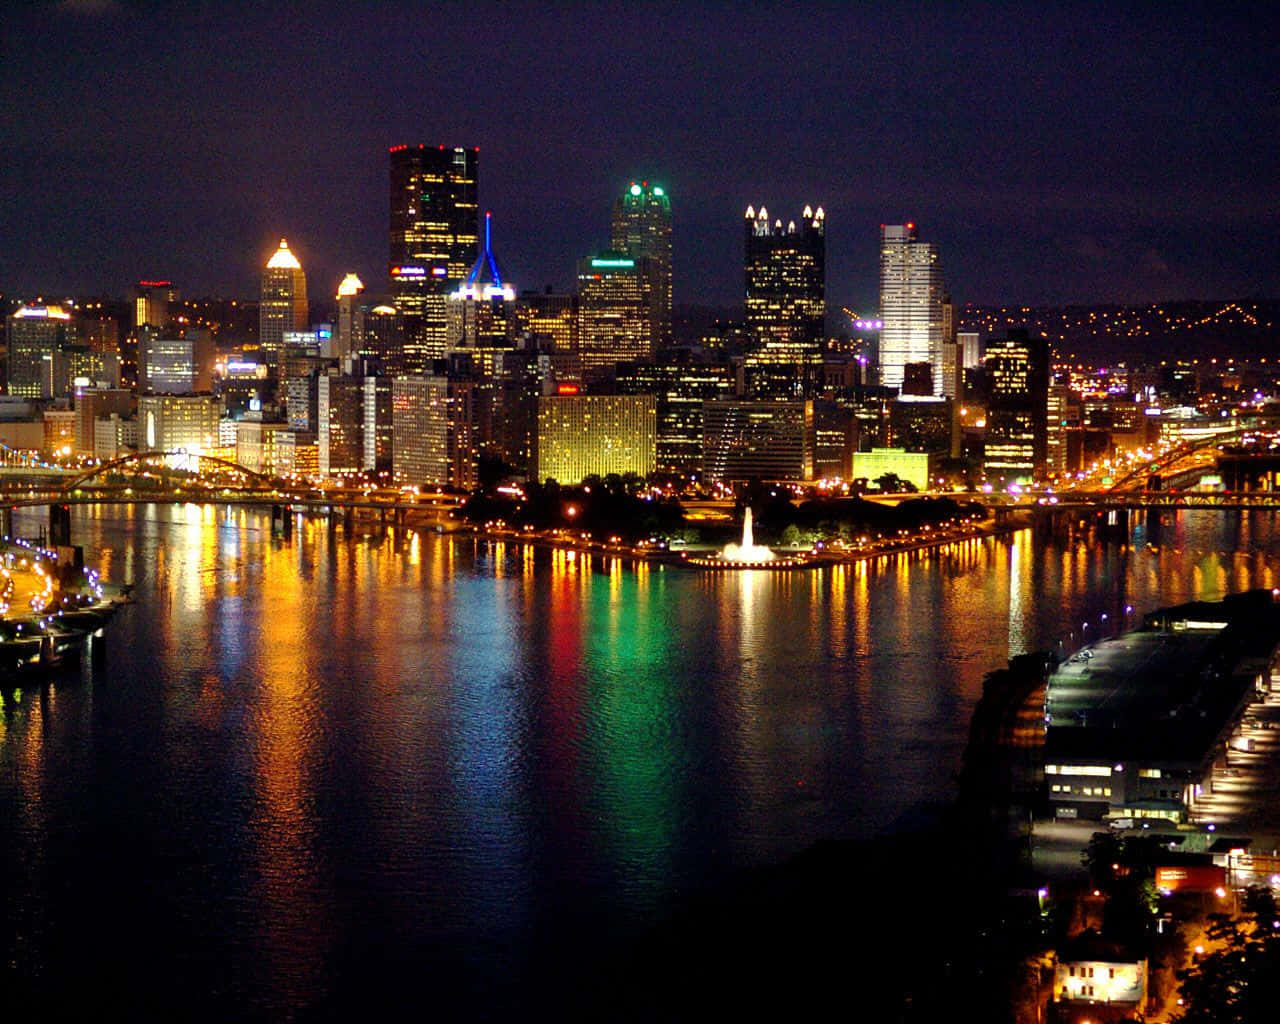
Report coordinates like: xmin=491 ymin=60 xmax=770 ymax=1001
xmin=0 ymin=0 xmax=1280 ymax=310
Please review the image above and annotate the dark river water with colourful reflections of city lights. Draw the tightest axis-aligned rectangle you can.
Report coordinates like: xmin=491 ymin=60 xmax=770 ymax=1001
xmin=0 ymin=506 xmax=1280 ymax=1020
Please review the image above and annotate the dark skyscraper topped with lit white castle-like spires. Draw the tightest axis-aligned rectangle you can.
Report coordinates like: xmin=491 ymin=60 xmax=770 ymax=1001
xmin=744 ymin=206 xmax=827 ymax=389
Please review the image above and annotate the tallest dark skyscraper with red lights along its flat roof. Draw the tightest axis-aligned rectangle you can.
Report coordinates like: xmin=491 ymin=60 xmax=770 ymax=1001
xmin=389 ymin=146 xmax=480 ymax=374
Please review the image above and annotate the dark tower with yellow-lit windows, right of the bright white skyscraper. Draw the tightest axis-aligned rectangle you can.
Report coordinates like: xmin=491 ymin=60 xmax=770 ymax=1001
xmin=983 ymin=330 xmax=1048 ymax=484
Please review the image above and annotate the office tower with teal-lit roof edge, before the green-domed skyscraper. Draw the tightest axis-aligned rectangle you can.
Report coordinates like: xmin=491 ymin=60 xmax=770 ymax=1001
xmin=577 ymin=251 xmax=653 ymax=376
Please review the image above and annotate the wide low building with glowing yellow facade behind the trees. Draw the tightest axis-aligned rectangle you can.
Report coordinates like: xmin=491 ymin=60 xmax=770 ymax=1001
xmin=530 ymin=394 xmax=657 ymax=484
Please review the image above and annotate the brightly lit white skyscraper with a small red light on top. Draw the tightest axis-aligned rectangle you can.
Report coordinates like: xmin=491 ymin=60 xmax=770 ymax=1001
xmin=879 ymin=224 xmax=945 ymax=394
